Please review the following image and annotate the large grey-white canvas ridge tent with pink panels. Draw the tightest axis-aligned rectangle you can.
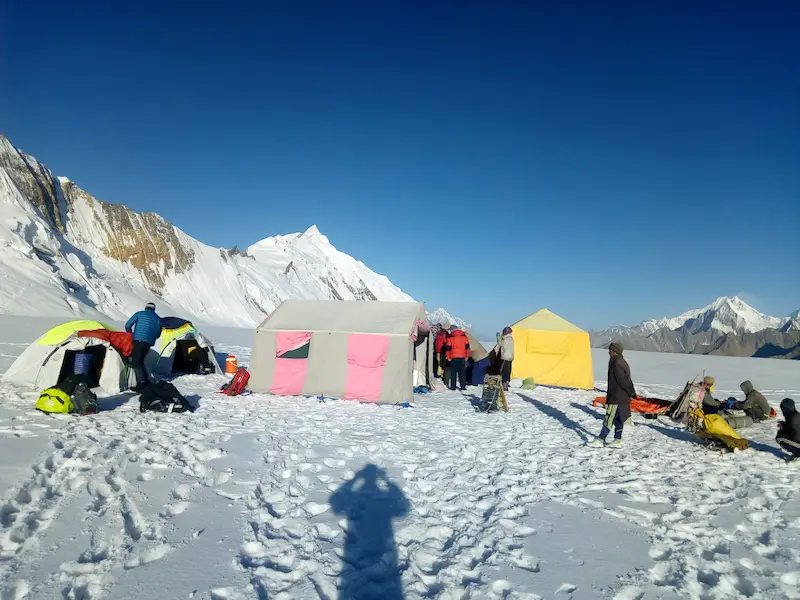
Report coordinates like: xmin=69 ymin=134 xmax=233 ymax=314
xmin=249 ymin=300 xmax=433 ymax=404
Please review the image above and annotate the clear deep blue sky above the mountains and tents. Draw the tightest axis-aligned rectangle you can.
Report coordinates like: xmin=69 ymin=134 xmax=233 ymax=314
xmin=0 ymin=0 xmax=800 ymax=333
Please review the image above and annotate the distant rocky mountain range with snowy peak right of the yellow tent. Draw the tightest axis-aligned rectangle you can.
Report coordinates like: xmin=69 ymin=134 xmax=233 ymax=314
xmin=589 ymin=296 xmax=800 ymax=359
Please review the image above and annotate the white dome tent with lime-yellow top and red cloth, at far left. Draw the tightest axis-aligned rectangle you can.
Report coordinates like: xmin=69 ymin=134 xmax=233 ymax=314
xmin=3 ymin=320 xmax=132 ymax=394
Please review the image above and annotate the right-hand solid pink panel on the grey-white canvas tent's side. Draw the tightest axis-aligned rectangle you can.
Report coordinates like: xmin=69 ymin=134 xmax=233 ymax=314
xmin=344 ymin=333 xmax=389 ymax=402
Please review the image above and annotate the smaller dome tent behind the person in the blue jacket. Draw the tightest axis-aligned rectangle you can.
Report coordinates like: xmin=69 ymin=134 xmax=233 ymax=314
xmin=145 ymin=317 xmax=224 ymax=377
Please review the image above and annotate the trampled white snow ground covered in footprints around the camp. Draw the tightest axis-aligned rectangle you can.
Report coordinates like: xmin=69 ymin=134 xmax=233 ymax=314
xmin=0 ymin=317 xmax=800 ymax=600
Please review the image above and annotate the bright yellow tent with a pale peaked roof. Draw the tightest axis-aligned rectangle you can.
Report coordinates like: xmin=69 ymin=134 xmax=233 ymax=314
xmin=511 ymin=308 xmax=594 ymax=390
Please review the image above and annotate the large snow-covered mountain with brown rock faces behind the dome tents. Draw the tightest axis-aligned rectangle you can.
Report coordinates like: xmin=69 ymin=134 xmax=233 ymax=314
xmin=0 ymin=135 xmax=412 ymax=327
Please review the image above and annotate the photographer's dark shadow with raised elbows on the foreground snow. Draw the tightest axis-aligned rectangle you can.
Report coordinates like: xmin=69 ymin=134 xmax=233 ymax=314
xmin=329 ymin=464 xmax=411 ymax=600
